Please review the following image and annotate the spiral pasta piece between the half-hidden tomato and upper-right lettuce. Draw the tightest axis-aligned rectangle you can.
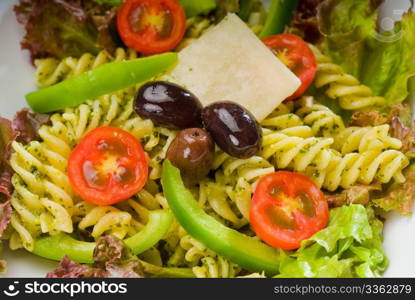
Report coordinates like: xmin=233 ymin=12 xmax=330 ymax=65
xmin=309 ymin=45 xmax=385 ymax=110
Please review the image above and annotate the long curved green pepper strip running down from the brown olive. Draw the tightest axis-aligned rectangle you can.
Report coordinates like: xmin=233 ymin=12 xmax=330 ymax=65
xmin=162 ymin=160 xmax=281 ymax=275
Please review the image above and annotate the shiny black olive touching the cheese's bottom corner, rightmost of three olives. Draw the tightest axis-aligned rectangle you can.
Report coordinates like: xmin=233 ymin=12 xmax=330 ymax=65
xmin=202 ymin=101 xmax=262 ymax=158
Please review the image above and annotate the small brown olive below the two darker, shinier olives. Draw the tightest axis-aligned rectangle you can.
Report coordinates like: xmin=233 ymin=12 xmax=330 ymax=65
xmin=166 ymin=128 xmax=215 ymax=185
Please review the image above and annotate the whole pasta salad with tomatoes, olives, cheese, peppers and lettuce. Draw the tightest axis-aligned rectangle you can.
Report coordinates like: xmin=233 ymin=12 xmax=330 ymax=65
xmin=0 ymin=0 xmax=415 ymax=278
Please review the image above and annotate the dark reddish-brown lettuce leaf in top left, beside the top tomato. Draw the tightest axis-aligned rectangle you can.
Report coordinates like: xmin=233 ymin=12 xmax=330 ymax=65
xmin=14 ymin=0 xmax=120 ymax=60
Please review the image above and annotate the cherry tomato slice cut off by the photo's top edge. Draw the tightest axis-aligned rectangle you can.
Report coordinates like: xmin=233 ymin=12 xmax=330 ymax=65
xmin=117 ymin=0 xmax=186 ymax=54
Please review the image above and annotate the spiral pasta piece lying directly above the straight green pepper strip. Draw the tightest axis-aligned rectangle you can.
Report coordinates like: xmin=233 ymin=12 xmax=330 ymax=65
xmin=35 ymin=48 xmax=137 ymax=87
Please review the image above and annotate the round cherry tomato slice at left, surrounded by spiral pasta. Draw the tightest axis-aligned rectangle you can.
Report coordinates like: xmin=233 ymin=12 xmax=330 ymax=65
xmin=68 ymin=127 xmax=148 ymax=205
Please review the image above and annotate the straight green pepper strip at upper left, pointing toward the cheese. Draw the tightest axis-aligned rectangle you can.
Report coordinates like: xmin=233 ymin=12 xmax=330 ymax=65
xmin=26 ymin=52 xmax=178 ymax=113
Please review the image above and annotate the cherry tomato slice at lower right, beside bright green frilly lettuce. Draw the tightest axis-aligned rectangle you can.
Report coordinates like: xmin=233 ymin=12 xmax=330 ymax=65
xmin=250 ymin=171 xmax=329 ymax=250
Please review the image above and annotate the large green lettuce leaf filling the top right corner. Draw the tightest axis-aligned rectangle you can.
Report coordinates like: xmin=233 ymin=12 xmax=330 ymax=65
xmin=318 ymin=0 xmax=415 ymax=106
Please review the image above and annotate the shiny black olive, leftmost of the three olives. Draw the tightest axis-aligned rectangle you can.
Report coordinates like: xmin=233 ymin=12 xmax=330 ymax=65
xmin=134 ymin=81 xmax=202 ymax=129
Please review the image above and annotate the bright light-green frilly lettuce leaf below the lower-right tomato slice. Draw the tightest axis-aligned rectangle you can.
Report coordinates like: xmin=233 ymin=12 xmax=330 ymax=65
xmin=277 ymin=204 xmax=388 ymax=277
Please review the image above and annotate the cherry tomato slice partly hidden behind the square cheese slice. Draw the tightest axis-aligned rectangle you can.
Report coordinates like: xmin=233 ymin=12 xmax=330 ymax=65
xmin=263 ymin=33 xmax=317 ymax=100
